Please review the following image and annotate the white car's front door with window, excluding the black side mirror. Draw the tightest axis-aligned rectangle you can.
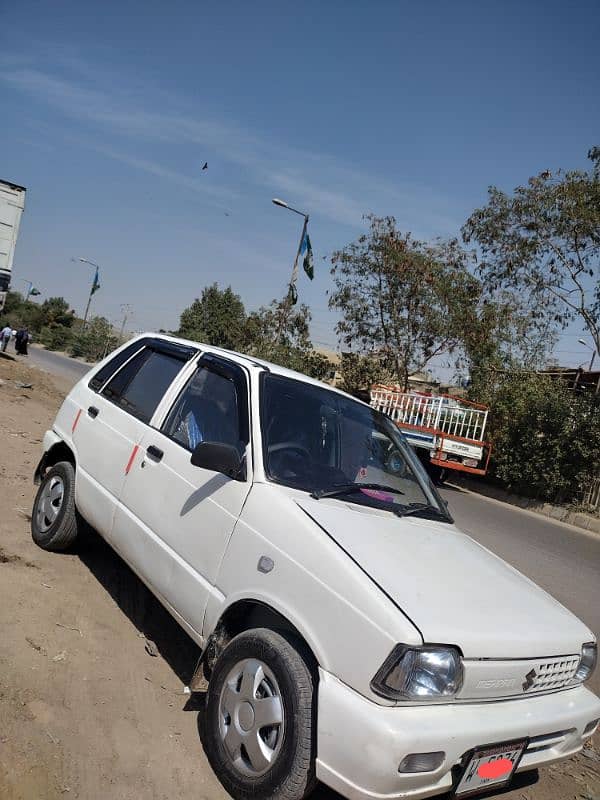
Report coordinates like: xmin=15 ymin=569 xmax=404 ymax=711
xmin=114 ymin=354 xmax=251 ymax=635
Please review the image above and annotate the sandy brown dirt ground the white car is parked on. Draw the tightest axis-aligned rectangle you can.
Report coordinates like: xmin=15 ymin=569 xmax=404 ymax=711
xmin=0 ymin=356 xmax=600 ymax=800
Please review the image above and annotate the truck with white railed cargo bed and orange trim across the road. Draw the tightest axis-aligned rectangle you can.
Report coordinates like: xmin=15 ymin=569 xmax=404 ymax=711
xmin=371 ymin=384 xmax=492 ymax=481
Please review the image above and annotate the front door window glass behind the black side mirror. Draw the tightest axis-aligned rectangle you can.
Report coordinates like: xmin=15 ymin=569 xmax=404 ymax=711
xmin=162 ymin=366 xmax=248 ymax=452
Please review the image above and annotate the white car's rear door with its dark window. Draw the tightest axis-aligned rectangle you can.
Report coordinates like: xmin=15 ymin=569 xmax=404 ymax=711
xmin=73 ymin=338 xmax=198 ymax=539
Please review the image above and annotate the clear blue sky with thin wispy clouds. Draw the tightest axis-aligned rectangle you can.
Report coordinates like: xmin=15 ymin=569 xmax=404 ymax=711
xmin=0 ymin=0 xmax=600 ymax=363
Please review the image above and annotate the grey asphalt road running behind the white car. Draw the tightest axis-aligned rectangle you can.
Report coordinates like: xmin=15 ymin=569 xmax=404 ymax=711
xmin=21 ymin=347 xmax=600 ymax=694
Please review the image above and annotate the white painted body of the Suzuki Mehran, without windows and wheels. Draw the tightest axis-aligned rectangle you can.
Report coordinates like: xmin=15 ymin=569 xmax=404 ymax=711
xmin=34 ymin=334 xmax=600 ymax=800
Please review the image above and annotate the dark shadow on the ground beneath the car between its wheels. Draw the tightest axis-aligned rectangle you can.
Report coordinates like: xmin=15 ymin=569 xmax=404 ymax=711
xmin=77 ymin=530 xmax=200 ymax=686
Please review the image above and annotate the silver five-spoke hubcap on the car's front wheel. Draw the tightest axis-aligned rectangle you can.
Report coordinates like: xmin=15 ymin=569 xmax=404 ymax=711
xmin=219 ymin=658 xmax=284 ymax=777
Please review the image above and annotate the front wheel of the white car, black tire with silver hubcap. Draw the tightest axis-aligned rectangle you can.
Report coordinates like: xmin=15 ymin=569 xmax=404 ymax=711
xmin=201 ymin=628 xmax=316 ymax=800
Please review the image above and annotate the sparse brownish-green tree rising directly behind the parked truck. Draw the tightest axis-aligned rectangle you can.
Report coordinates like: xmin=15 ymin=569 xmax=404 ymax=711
xmin=329 ymin=215 xmax=480 ymax=387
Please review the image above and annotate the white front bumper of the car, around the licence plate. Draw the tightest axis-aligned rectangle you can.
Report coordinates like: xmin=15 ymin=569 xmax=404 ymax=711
xmin=317 ymin=670 xmax=600 ymax=800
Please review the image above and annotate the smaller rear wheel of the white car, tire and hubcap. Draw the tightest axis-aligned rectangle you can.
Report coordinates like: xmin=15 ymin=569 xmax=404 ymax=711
xmin=31 ymin=461 xmax=79 ymax=550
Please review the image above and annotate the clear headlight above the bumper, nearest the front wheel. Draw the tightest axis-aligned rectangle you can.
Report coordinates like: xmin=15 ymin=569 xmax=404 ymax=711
xmin=371 ymin=644 xmax=463 ymax=701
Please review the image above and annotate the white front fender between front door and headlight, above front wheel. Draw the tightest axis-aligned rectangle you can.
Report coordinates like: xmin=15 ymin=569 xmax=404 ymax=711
xmin=211 ymin=484 xmax=422 ymax=701
